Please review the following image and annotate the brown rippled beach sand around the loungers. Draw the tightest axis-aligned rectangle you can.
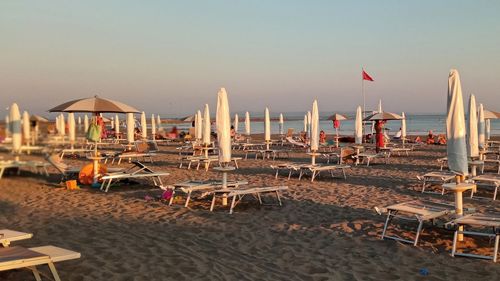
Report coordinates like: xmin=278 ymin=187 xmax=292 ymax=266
xmin=0 ymin=138 xmax=500 ymax=281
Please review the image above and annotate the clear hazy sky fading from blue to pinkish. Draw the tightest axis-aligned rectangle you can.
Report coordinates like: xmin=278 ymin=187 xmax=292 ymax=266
xmin=0 ymin=0 xmax=500 ymax=116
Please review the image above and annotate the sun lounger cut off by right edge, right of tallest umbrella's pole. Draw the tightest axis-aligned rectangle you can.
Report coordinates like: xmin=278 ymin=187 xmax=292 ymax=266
xmin=448 ymin=214 xmax=500 ymax=262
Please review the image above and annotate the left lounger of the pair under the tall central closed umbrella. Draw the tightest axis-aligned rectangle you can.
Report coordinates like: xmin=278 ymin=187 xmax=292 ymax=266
xmin=163 ymin=180 xmax=248 ymax=207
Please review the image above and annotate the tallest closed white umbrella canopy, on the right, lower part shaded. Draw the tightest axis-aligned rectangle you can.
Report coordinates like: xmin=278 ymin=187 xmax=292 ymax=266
xmin=446 ymin=69 xmax=469 ymax=176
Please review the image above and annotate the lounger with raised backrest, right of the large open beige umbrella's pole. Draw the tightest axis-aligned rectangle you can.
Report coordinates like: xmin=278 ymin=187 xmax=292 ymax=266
xmin=100 ymin=161 xmax=169 ymax=192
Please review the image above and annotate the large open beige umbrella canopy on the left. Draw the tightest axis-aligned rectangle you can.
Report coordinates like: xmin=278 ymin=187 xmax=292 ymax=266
xmin=49 ymin=96 xmax=139 ymax=113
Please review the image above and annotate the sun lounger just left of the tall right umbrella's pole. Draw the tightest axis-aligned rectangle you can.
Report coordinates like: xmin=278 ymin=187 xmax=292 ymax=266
xmin=375 ymin=200 xmax=455 ymax=246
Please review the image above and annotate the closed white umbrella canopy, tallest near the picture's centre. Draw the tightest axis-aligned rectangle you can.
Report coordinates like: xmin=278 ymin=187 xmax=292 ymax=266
xmin=215 ymin=88 xmax=231 ymax=163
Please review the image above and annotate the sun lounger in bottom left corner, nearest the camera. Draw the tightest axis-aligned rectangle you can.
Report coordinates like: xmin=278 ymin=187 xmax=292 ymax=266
xmin=0 ymin=246 xmax=81 ymax=281
